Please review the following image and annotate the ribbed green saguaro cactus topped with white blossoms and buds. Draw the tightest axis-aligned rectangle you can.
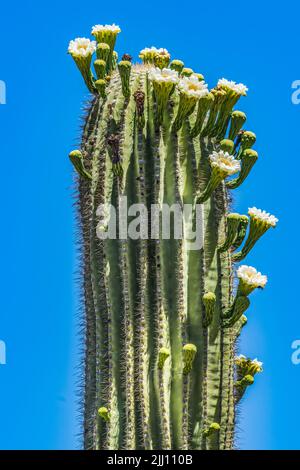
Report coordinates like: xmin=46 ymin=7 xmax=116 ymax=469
xmin=69 ymin=25 xmax=277 ymax=449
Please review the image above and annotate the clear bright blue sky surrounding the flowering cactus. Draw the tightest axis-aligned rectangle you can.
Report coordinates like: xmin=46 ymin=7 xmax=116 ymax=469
xmin=0 ymin=0 xmax=300 ymax=449
